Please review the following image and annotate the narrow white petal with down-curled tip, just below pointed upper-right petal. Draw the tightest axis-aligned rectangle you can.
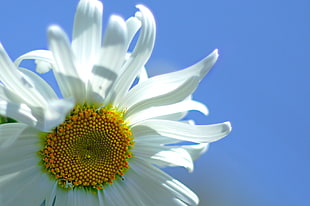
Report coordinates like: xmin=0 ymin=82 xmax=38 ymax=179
xmin=127 ymin=100 xmax=208 ymax=124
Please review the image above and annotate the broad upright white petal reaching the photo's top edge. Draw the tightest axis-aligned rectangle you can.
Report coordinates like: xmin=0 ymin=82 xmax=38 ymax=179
xmin=72 ymin=0 xmax=103 ymax=73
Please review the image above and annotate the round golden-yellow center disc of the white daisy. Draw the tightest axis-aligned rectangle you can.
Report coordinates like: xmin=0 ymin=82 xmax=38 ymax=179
xmin=40 ymin=105 xmax=133 ymax=189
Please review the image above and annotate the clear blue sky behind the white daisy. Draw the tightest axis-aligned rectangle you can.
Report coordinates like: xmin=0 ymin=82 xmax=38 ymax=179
xmin=0 ymin=0 xmax=310 ymax=206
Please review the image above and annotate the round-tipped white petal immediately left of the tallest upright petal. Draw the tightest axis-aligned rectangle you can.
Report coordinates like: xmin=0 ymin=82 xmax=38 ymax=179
xmin=48 ymin=26 xmax=87 ymax=103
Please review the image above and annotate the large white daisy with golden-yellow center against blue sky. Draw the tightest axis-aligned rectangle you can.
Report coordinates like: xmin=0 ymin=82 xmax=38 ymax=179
xmin=0 ymin=0 xmax=231 ymax=206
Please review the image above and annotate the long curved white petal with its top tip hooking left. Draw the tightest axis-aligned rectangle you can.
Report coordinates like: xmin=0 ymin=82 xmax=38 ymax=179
xmin=109 ymin=5 xmax=156 ymax=104
